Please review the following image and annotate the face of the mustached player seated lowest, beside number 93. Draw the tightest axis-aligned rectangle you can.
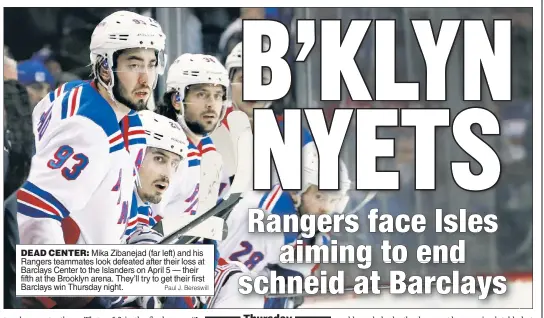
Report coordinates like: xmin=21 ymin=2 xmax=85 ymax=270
xmin=138 ymin=147 xmax=181 ymax=204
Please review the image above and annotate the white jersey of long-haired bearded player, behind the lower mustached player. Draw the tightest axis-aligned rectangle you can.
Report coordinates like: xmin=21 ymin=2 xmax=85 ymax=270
xmin=151 ymin=136 xmax=230 ymax=226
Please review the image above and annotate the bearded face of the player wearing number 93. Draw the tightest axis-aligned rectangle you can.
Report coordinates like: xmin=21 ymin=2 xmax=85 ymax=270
xmin=113 ymin=49 xmax=157 ymax=110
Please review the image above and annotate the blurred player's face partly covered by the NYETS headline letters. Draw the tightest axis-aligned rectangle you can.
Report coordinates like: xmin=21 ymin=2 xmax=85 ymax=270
xmin=300 ymin=185 xmax=341 ymax=215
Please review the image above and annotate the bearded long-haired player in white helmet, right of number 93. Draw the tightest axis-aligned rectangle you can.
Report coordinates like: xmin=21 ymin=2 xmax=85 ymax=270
xmin=155 ymin=53 xmax=229 ymax=222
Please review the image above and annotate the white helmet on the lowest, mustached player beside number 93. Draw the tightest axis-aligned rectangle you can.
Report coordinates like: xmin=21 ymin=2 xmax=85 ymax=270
xmin=138 ymin=110 xmax=189 ymax=160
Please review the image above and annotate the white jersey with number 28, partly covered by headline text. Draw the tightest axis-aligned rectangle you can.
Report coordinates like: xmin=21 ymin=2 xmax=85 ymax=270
xmin=219 ymin=184 xmax=330 ymax=276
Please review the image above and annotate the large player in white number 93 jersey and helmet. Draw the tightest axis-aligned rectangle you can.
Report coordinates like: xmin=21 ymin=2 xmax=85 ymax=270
xmin=18 ymin=11 xmax=165 ymax=244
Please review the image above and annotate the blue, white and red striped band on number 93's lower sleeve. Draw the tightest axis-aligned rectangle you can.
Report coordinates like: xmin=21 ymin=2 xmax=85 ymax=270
xmin=17 ymin=181 xmax=70 ymax=221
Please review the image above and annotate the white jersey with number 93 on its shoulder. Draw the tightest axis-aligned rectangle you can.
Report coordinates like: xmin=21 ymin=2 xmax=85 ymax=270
xmin=17 ymin=81 xmax=146 ymax=244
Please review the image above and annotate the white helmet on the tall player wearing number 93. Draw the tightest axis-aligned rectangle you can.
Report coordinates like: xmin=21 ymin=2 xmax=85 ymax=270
xmin=89 ymin=11 xmax=166 ymax=88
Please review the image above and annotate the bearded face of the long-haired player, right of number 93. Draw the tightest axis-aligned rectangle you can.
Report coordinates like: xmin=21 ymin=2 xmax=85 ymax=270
xmin=184 ymin=84 xmax=225 ymax=135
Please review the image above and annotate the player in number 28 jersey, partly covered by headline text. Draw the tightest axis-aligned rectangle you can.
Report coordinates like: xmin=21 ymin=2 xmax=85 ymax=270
xmin=219 ymin=146 xmax=350 ymax=308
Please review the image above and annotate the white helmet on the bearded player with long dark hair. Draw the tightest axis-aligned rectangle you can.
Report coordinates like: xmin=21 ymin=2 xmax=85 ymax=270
xmin=166 ymin=53 xmax=230 ymax=129
